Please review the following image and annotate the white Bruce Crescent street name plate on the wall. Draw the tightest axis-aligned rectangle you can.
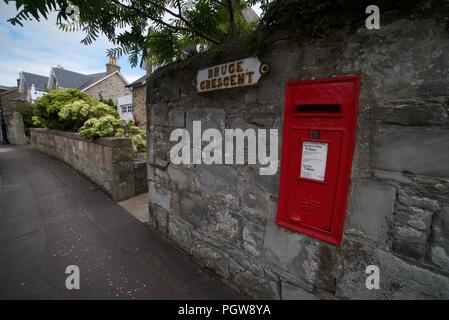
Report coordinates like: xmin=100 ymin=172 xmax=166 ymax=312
xmin=196 ymin=57 xmax=269 ymax=92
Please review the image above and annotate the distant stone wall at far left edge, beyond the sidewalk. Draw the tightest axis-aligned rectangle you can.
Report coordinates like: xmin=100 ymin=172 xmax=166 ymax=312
xmin=0 ymin=89 xmax=29 ymax=145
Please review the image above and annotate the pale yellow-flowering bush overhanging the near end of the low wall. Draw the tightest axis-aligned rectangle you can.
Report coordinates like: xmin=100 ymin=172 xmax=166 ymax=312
xmin=79 ymin=115 xmax=146 ymax=152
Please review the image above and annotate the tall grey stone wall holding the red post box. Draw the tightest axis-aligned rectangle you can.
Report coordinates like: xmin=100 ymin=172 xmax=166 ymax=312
xmin=147 ymin=18 xmax=449 ymax=299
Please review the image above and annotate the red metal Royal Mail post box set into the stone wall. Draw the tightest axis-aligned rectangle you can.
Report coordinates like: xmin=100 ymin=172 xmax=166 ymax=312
xmin=276 ymin=76 xmax=360 ymax=245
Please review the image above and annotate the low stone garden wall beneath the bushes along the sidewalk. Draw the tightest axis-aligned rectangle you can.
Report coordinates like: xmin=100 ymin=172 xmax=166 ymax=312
xmin=31 ymin=129 xmax=146 ymax=201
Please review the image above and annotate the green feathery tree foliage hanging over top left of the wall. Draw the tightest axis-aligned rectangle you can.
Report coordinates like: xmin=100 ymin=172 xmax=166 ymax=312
xmin=4 ymin=0 xmax=268 ymax=66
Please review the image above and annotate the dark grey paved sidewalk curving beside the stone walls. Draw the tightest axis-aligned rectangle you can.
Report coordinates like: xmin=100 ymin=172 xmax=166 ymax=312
xmin=0 ymin=146 xmax=244 ymax=299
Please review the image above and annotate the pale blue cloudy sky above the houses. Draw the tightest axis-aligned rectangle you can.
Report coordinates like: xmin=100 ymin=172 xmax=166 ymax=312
xmin=0 ymin=1 xmax=260 ymax=86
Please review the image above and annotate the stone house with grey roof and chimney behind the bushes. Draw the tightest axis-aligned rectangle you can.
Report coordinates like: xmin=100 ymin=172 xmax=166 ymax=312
xmin=47 ymin=58 xmax=129 ymax=105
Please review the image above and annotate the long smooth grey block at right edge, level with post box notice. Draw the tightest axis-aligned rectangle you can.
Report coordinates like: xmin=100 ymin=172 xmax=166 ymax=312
xmin=372 ymin=127 xmax=449 ymax=177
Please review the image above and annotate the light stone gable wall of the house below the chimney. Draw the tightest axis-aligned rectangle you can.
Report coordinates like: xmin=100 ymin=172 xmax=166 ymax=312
xmin=85 ymin=73 xmax=129 ymax=104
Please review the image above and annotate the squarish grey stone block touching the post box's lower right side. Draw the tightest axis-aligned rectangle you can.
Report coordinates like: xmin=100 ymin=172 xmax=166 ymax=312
xmin=346 ymin=180 xmax=396 ymax=243
